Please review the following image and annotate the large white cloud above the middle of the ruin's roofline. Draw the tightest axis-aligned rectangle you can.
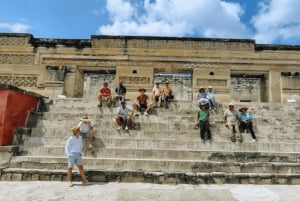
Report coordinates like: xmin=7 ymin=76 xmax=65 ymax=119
xmin=98 ymin=0 xmax=249 ymax=38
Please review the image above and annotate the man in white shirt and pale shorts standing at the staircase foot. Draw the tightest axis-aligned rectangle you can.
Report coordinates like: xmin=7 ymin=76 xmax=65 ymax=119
xmin=65 ymin=126 xmax=88 ymax=187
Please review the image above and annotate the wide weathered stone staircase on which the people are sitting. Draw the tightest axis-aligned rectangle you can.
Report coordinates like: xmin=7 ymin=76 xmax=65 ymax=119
xmin=1 ymin=74 xmax=300 ymax=184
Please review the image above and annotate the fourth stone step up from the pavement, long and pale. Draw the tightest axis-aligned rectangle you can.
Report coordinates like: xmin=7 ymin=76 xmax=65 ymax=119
xmin=20 ymin=137 xmax=300 ymax=152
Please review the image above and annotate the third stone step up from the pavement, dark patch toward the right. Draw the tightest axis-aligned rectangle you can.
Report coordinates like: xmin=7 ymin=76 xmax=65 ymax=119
xmin=20 ymin=146 xmax=300 ymax=163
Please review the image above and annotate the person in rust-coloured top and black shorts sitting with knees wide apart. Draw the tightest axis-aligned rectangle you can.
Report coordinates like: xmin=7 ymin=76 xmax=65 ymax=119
xmin=132 ymin=88 xmax=152 ymax=116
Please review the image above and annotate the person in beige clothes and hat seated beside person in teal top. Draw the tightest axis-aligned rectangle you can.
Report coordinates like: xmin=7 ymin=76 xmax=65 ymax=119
xmin=224 ymin=103 xmax=243 ymax=142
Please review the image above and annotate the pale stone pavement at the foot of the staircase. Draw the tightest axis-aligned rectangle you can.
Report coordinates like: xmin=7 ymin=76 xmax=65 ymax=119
xmin=0 ymin=181 xmax=300 ymax=201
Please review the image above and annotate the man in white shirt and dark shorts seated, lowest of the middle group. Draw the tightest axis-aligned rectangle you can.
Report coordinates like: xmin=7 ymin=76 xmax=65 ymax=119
xmin=116 ymin=101 xmax=132 ymax=130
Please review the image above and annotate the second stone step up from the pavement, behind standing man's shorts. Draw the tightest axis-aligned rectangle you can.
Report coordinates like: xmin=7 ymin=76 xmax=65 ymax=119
xmin=9 ymin=156 xmax=300 ymax=174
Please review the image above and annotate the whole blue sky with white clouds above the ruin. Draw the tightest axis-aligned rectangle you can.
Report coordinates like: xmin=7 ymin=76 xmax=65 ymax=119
xmin=0 ymin=0 xmax=300 ymax=45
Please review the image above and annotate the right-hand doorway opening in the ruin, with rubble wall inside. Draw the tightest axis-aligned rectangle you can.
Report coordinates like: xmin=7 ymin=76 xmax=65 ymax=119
xmin=230 ymin=72 xmax=268 ymax=102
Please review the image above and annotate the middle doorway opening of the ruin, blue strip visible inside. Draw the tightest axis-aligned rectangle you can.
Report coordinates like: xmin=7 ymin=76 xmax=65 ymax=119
xmin=153 ymin=69 xmax=193 ymax=101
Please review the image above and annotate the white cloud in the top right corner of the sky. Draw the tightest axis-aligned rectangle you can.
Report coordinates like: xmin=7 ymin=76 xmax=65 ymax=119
xmin=252 ymin=0 xmax=300 ymax=43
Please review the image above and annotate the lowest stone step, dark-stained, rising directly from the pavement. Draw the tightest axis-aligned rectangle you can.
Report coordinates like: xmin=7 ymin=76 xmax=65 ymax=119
xmin=1 ymin=168 xmax=300 ymax=185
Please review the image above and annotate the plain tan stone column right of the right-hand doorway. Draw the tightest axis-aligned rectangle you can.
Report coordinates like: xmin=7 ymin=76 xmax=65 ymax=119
xmin=268 ymin=71 xmax=282 ymax=103
